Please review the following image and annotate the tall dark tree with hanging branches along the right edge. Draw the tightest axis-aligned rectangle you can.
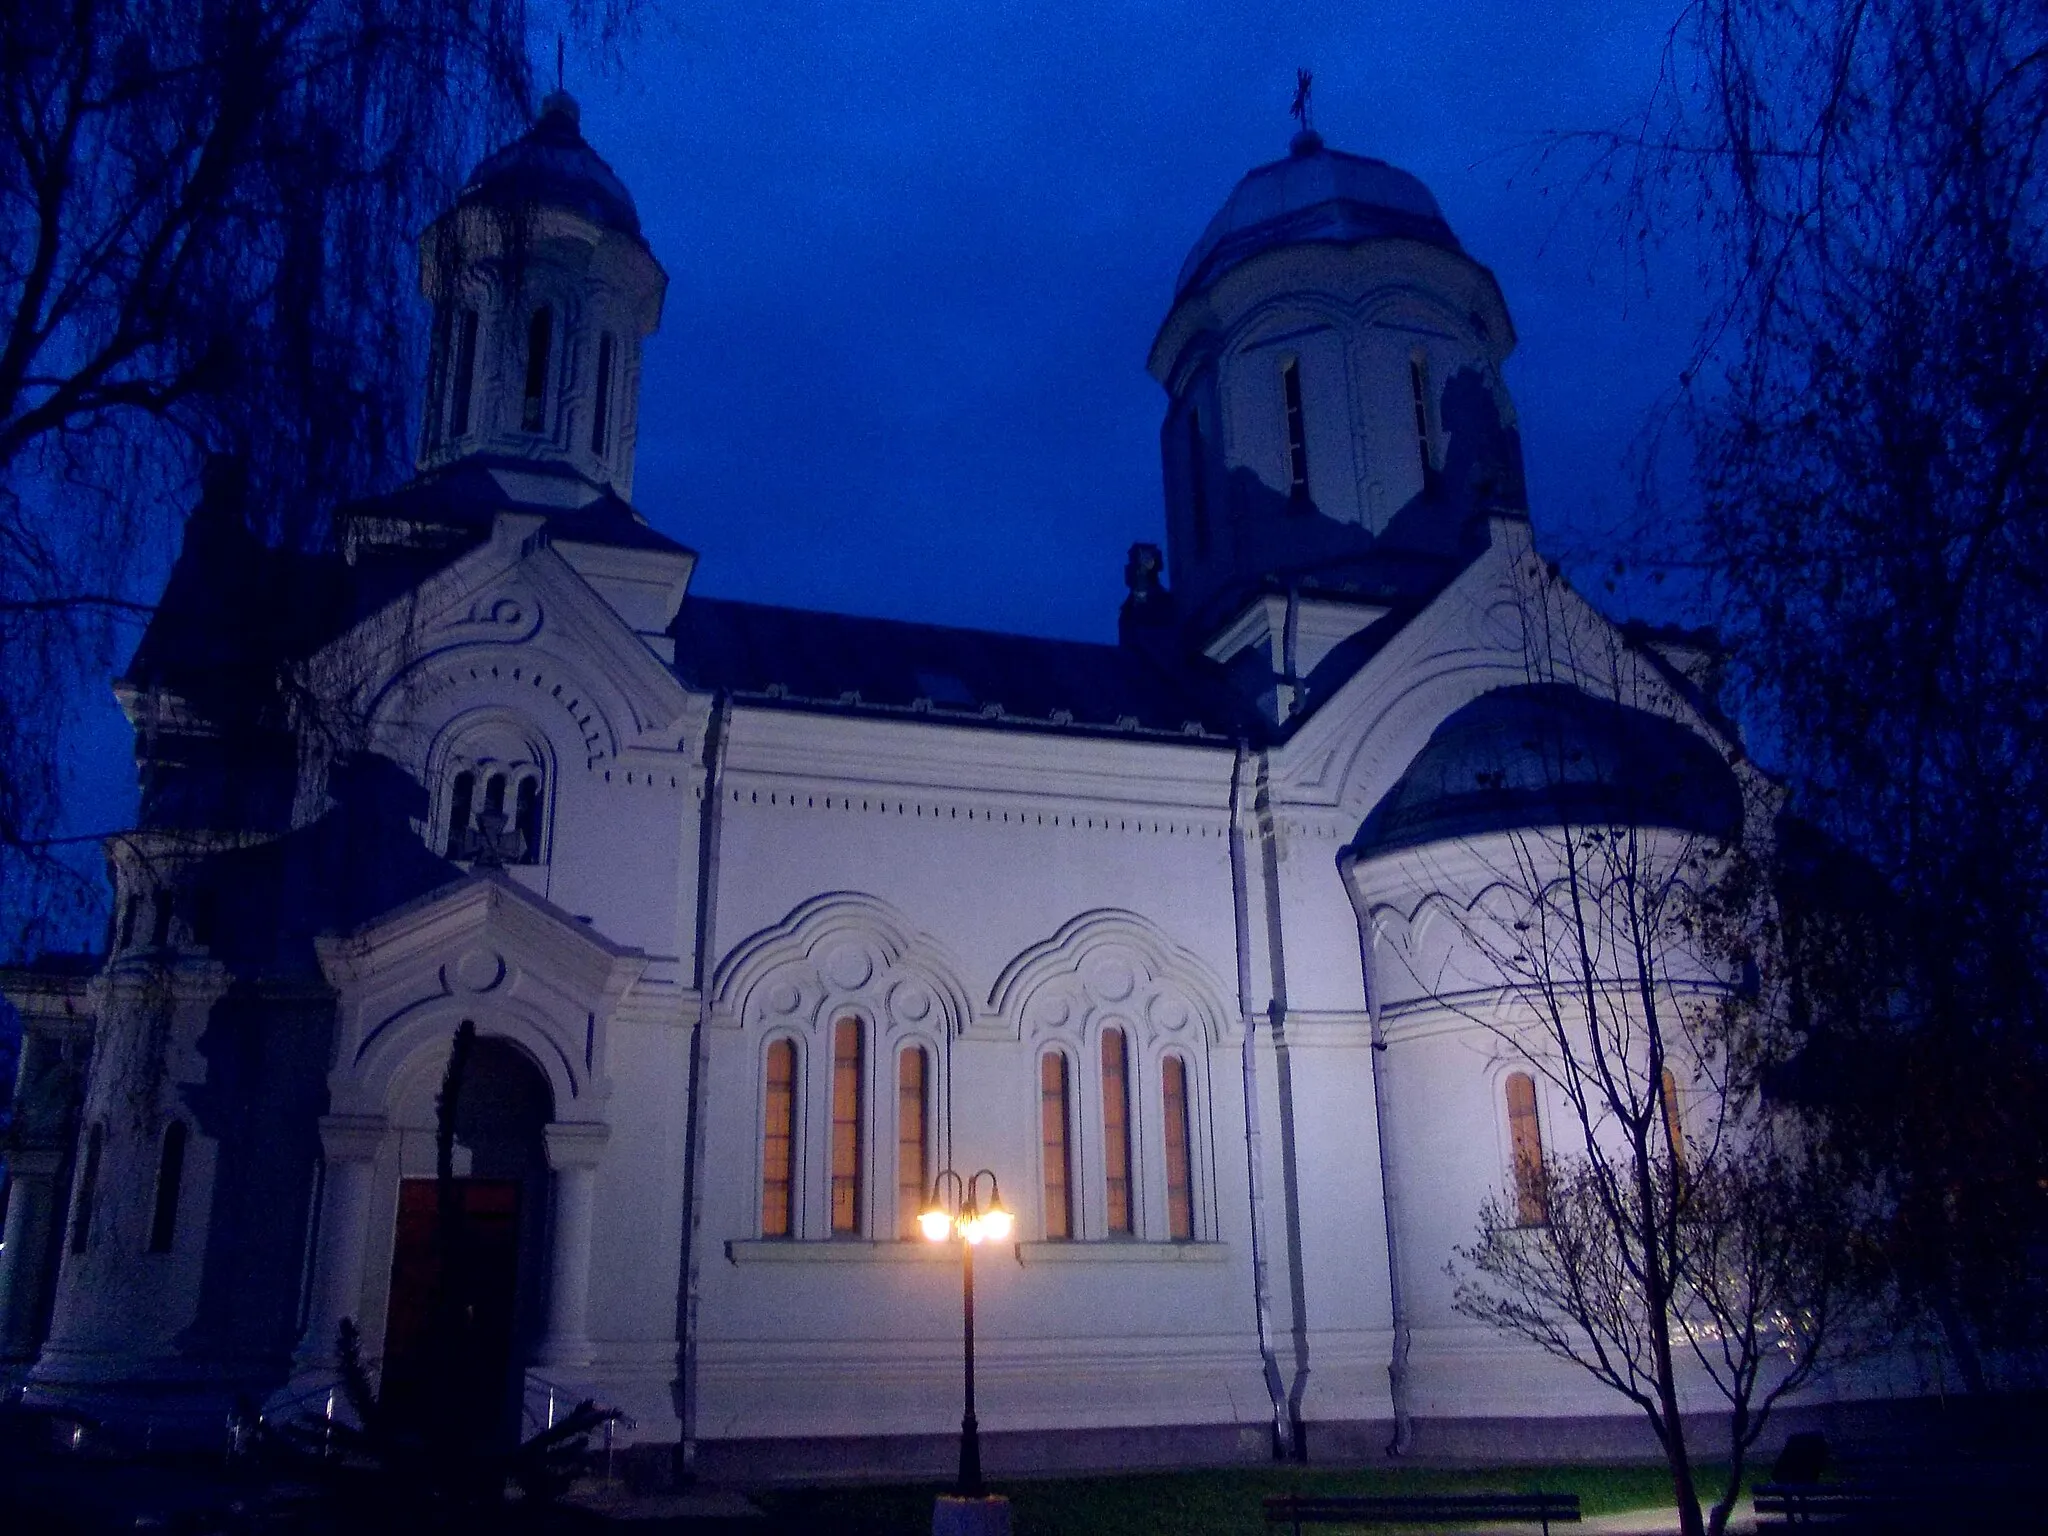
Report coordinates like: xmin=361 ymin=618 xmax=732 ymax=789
xmin=1548 ymin=0 xmax=2048 ymax=1391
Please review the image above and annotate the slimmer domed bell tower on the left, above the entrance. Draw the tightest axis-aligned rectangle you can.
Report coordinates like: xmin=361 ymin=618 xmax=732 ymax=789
xmin=420 ymin=90 xmax=668 ymax=500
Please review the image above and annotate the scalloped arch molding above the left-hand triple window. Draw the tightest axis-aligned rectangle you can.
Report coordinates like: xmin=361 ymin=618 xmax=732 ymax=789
xmin=711 ymin=891 xmax=975 ymax=1038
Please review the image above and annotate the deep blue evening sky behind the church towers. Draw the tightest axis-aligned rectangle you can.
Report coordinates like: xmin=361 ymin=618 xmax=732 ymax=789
xmin=565 ymin=0 xmax=1696 ymax=639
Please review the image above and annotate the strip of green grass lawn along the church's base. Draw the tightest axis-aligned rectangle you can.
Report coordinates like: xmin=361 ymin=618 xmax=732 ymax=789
xmin=750 ymin=1466 xmax=1718 ymax=1536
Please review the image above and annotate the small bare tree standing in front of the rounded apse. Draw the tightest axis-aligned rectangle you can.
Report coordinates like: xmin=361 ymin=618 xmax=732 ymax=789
xmin=1425 ymin=559 xmax=1851 ymax=1536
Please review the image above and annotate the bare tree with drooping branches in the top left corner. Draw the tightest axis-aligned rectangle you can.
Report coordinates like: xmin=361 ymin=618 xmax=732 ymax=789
xmin=0 ymin=0 xmax=633 ymax=962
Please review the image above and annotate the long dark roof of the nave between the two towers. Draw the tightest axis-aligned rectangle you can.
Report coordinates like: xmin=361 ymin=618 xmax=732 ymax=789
xmin=672 ymin=598 xmax=1255 ymax=741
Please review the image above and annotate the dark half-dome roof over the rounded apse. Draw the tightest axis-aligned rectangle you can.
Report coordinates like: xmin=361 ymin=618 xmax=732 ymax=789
xmin=1352 ymin=682 xmax=1743 ymax=856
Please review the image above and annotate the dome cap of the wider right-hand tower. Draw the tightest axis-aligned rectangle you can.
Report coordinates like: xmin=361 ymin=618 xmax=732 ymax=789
xmin=1174 ymin=129 xmax=1464 ymax=299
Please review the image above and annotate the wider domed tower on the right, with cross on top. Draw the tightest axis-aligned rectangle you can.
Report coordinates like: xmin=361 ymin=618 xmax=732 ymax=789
xmin=1149 ymin=127 xmax=1522 ymax=643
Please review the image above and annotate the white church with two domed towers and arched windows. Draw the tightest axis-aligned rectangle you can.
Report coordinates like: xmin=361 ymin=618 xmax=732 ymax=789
xmin=0 ymin=94 xmax=1777 ymax=1475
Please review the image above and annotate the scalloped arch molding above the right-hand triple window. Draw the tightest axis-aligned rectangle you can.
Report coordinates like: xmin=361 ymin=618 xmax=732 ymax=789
xmin=989 ymin=907 xmax=1229 ymax=1044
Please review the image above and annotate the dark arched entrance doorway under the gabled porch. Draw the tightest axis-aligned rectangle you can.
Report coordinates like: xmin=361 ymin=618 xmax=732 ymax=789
xmin=383 ymin=1034 xmax=553 ymax=1444
